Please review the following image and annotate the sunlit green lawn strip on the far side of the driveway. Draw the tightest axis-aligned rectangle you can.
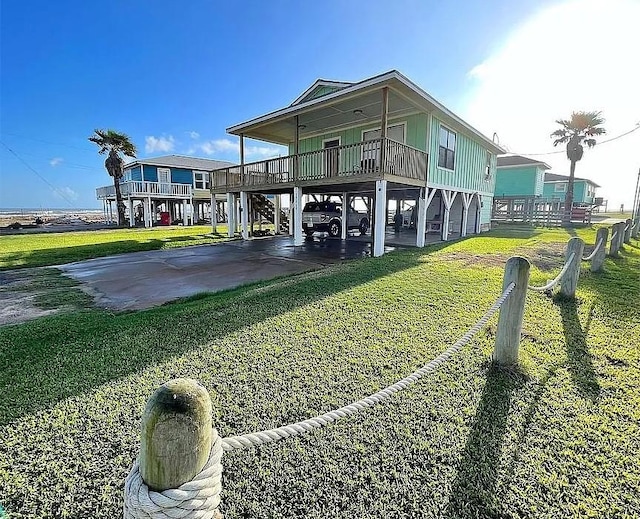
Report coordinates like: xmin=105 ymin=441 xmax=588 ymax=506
xmin=0 ymin=225 xmax=226 ymax=270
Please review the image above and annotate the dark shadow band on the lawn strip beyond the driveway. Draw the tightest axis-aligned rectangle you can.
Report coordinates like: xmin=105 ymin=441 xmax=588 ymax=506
xmin=0 ymin=235 xmax=224 ymax=270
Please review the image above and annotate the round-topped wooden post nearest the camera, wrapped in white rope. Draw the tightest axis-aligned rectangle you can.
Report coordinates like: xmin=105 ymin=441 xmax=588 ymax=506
xmin=124 ymin=378 xmax=222 ymax=519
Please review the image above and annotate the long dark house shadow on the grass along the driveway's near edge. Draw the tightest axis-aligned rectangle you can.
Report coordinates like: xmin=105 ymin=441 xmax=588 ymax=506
xmin=0 ymin=243 xmax=460 ymax=425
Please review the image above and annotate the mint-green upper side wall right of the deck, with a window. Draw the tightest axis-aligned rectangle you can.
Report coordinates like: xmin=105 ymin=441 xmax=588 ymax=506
xmin=429 ymin=117 xmax=497 ymax=194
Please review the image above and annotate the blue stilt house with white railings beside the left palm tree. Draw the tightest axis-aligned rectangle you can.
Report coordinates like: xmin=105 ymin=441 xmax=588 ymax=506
xmin=96 ymin=155 xmax=231 ymax=227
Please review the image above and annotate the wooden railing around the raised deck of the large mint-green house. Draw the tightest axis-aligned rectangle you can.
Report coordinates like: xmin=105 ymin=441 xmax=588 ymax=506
xmin=211 ymin=139 xmax=427 ymax=189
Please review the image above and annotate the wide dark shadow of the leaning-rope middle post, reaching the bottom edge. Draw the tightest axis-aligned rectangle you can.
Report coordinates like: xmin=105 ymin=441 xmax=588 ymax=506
xmin=444 ymin=364 xmax=535 ymax=519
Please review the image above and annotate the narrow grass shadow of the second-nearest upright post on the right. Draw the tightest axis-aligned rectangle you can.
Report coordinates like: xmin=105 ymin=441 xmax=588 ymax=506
xmin=554 ymin=295 xmax=600 ymax=402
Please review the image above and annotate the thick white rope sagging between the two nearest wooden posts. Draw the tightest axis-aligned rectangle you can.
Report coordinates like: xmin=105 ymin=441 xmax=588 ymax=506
xmin=222 ymin=283 xmax=516 ymax=451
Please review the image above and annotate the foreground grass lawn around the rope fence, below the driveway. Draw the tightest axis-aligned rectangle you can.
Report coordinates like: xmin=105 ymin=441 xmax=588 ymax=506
xmin=0 ymin=228 xmax=640 ymax=519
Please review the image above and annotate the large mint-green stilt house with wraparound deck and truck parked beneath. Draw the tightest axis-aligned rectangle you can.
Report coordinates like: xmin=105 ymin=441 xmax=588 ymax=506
xmin=211 ymin=70 xmax=504 ymax=256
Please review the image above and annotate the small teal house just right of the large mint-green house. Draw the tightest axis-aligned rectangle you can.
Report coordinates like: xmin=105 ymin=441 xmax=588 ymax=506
xmin=494 ymin=155 xmax=551 ymax=198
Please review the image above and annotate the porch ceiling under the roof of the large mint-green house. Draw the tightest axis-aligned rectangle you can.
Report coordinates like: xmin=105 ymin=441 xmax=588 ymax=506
xmin=238 ymin=89 xmax=419 ymax=145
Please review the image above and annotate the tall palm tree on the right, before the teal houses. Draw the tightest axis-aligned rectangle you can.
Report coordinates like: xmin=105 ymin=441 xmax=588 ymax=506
xmin=551 ymin=112 xmax=607 ymax=224
